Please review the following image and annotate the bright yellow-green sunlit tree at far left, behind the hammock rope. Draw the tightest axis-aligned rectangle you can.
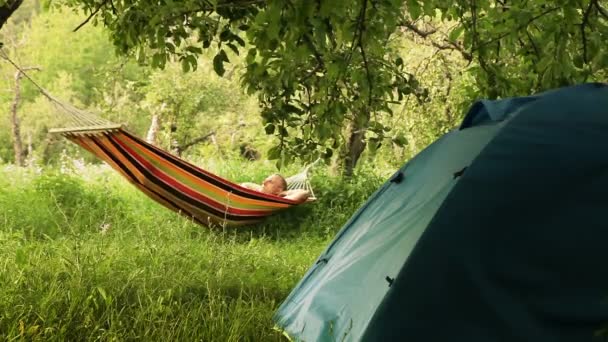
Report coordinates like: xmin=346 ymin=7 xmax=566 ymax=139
xmin=0 ymin=6 xmax=140 ymax=165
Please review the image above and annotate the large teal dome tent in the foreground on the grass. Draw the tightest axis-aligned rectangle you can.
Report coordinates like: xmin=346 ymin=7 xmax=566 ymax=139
xmin=275 ymin=83 xmax=608 ymax=342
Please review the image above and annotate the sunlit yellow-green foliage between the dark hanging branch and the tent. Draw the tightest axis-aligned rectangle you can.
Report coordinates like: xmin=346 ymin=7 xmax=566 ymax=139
xmin=363 ymin=25 xmax=479 ymax=169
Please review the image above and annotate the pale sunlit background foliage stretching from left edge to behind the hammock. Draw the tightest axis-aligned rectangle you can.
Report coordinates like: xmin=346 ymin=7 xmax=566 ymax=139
xmin=0 ymin=1 xmax=268 ymax=164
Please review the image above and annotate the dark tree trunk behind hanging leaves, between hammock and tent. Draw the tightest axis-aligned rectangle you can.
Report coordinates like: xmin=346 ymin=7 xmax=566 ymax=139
xmin=341 ymin=112 xmax=370 ymax=178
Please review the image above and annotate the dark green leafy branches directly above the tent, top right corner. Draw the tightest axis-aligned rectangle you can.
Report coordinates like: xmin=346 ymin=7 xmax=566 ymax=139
xmin=409 ymin=0 xmax=608 ymax=98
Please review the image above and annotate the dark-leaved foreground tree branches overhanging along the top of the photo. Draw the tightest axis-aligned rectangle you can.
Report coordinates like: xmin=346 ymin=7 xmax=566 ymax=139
xmin=48 ymin=0 xmax=608 ymax=175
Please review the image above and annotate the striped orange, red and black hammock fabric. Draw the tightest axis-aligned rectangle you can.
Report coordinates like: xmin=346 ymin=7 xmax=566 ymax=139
xmin=54 ymin=125 xmax=306 ymax=226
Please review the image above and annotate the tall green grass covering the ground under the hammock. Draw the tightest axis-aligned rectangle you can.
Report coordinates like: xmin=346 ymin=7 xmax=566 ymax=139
xmin=0 ymin=161 xmax=381 ymax=341
